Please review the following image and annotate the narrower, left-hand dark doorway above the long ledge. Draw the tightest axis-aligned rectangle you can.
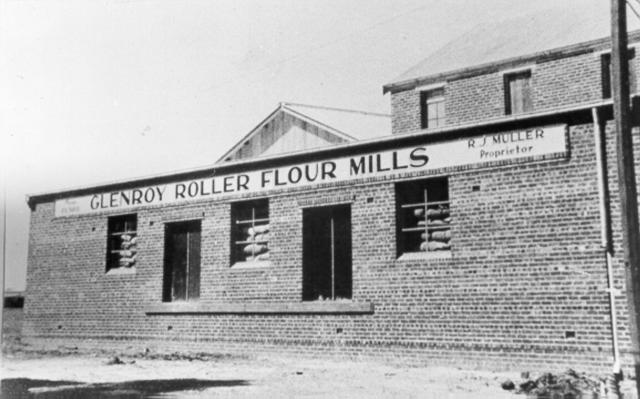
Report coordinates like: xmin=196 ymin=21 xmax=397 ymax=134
xmin=162 ymin=220 xmax=200 ymax=302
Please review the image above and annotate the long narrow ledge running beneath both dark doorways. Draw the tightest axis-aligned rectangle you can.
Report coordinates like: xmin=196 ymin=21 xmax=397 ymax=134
xmin=145 ymin=301 xmax=374 ymax=315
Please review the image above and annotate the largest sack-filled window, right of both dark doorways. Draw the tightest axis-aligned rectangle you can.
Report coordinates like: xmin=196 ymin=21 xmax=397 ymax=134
xmin=396 ymin=177 xmax=451 ymax=256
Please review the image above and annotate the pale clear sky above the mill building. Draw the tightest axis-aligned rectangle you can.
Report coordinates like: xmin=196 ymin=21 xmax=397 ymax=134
xmin=0 ymin=0 xmax=640 ymax=290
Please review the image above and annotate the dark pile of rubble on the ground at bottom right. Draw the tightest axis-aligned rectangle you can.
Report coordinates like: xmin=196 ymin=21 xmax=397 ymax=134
xmin=502 ymin=369 xmax=602 ymax=399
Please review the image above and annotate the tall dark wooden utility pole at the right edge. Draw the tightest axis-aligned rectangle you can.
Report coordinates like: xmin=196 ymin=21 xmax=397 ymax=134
xmin=611 ymin=0 xmax=640 ymax=390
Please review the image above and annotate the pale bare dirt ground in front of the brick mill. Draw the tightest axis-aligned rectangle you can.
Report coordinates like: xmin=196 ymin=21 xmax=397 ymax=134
xmin=1 ymin=340 xmax=525 ymax=399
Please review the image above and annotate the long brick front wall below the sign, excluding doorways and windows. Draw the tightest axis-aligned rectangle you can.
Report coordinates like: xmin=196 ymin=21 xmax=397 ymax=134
xmin=24 ymin=124 xmax=628 ymax=372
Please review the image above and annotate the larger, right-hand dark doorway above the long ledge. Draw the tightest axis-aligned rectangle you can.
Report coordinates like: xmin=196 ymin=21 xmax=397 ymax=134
xmin=302 ymin=205 xmax=352 ymax=301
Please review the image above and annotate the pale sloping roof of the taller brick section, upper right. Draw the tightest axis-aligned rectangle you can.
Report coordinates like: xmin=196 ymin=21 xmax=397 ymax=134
xmin=384 ymin=1 xmax=640 ymax=92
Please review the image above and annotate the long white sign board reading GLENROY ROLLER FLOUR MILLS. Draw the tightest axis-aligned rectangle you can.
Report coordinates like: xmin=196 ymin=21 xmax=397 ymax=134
xmin=55 ymin=125 xmax=567 ymax=217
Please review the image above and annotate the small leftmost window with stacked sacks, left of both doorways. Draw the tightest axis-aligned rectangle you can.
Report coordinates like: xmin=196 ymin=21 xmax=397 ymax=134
xmin=107 ymin=214 xmax=138 ymax=271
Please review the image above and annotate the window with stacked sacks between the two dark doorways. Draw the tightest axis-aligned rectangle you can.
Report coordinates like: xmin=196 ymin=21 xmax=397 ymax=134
xmin=231 ymin=199 xmax=269 ymax=265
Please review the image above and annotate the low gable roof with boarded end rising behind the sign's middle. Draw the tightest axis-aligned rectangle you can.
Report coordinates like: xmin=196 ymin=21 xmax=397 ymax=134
xmin=217 ymin=103 xmax=391 ymax=163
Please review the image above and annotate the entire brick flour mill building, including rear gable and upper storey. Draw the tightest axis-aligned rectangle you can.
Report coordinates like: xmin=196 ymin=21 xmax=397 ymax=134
xmin=24 ymin=18 xmax=640 ymax=372
